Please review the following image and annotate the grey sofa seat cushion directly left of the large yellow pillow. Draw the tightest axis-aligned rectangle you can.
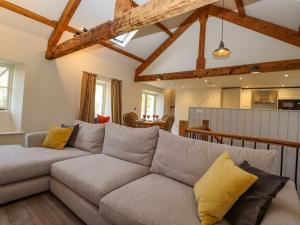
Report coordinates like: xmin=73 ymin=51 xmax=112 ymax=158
xmin=100 ymin=174 xmax=227 ymax=225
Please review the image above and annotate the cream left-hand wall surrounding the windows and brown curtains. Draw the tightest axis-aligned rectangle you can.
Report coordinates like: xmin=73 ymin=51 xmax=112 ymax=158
xmin=0 ymin=25 xmax=162 ymax=144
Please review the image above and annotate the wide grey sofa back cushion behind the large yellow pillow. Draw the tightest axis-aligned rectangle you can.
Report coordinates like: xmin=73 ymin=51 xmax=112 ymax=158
xmin=150 ymin=130 xmax=277 ymax=186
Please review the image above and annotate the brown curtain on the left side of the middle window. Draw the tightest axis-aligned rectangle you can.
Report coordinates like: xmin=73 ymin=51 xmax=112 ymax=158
xmin=78 ymin=72 xmax=97 ymax=123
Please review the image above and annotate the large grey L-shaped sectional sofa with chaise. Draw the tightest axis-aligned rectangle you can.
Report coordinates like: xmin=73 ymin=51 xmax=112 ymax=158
xmin=0 ymin=123 xmax=300 ymax=225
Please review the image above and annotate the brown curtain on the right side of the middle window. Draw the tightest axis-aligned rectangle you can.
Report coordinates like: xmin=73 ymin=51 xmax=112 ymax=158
xmin=111 ymin=79 xmax=122 ymax=124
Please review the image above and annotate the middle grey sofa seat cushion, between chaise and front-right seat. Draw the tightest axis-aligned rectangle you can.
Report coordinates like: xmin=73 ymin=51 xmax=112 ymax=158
xmin=51 ymin=154 xmax=149 ymax=205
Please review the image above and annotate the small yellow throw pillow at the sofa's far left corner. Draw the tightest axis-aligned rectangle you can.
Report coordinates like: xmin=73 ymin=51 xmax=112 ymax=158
xmin=42 ymin=126 xmax=74 ymax=149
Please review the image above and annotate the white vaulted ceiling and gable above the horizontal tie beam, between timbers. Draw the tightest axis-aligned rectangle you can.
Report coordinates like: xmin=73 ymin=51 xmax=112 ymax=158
xmin=0 ymin=0 xmax=300 ymax=89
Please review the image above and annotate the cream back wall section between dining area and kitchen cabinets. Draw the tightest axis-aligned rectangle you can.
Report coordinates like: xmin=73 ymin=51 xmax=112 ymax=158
xmin=173 ymin=88 xmax=222 ymax=133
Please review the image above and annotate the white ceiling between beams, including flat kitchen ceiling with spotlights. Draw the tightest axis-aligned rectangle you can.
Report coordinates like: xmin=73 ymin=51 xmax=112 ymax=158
xmin=0 ymin=0 xmax=300 ymax=88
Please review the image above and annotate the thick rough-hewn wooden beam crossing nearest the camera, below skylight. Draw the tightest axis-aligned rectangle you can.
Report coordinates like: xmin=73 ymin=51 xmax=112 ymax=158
xmin=46 ymin=0 xmax=218 ymax=59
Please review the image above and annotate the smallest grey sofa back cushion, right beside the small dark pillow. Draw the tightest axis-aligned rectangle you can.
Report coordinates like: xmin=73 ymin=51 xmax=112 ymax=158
xmin=74 ymin=120 xmax=105 ymax=154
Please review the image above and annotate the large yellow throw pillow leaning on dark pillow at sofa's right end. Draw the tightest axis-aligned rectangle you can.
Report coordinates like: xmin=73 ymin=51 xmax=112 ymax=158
xmin=194 ymin=152 xmax=258 ymax=225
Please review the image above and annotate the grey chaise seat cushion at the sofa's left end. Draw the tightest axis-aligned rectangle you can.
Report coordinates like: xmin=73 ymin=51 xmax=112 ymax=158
xmin=0 ymin=145 xmax=90 ymax=185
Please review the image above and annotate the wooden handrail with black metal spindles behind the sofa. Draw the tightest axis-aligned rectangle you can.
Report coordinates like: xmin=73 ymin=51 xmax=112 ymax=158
xmin=184 ymin=128 xmax=300 ymax=187
